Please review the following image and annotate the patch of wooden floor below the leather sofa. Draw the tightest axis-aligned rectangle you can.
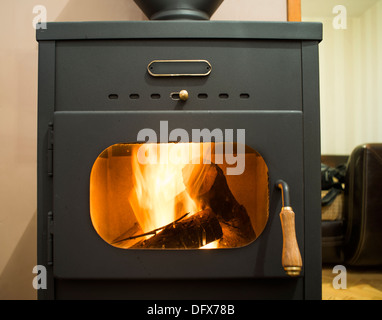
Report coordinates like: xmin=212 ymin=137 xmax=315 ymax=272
xmin=322 ymin=268 xmax=382 ymax=300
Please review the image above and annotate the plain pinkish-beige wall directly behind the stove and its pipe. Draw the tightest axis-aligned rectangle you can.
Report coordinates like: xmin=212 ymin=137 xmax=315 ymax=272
xmin=0 ymin=0 xmax=286 ymax=299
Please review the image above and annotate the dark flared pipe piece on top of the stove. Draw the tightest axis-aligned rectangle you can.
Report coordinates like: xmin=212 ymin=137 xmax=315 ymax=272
xmin=134 ymin=0 xmax=224 ymax=20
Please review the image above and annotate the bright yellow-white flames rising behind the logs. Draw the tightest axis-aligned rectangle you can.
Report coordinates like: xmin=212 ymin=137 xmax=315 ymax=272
xmin=129 ymin=143 xmax=198 ymax=232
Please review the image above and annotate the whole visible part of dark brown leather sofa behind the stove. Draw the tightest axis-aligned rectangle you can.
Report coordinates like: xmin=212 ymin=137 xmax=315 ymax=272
xmin=321 ymin=144 xmax=382 ymax=267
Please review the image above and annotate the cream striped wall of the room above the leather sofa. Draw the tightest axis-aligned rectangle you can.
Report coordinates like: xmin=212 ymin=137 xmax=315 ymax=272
xmin=302 ymin=0 xmax=382 ymax=154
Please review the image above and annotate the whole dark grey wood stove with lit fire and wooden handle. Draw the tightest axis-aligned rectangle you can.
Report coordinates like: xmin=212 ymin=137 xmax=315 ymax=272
xmin=37 ymin=1 xmax=322 ymax=299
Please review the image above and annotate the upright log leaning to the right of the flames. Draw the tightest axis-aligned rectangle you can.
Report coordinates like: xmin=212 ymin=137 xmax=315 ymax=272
xmin=183 ymin=164 xmax=256 ymax=247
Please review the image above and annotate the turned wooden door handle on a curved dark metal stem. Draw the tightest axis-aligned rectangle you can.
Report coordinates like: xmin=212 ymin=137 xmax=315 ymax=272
xmin=276 ymin=180 xmax=302 ymax=277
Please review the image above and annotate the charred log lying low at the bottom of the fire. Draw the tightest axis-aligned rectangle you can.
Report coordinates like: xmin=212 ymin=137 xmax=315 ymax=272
xmin=131 ymin=208 xmax=223 ymax=249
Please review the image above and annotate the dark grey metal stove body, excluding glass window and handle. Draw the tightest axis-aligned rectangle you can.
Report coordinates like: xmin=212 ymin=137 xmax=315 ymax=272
xmin=37 ymin=21 xmax=322 ymax=299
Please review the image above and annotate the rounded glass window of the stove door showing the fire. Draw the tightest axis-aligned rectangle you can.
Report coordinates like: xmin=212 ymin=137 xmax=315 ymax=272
xmin=90 ymin=143 xmax=269 ymax=249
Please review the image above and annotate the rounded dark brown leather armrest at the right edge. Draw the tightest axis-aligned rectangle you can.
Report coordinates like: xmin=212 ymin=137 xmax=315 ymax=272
xmin=344 ymin=144 xmax=382 ymax=266
